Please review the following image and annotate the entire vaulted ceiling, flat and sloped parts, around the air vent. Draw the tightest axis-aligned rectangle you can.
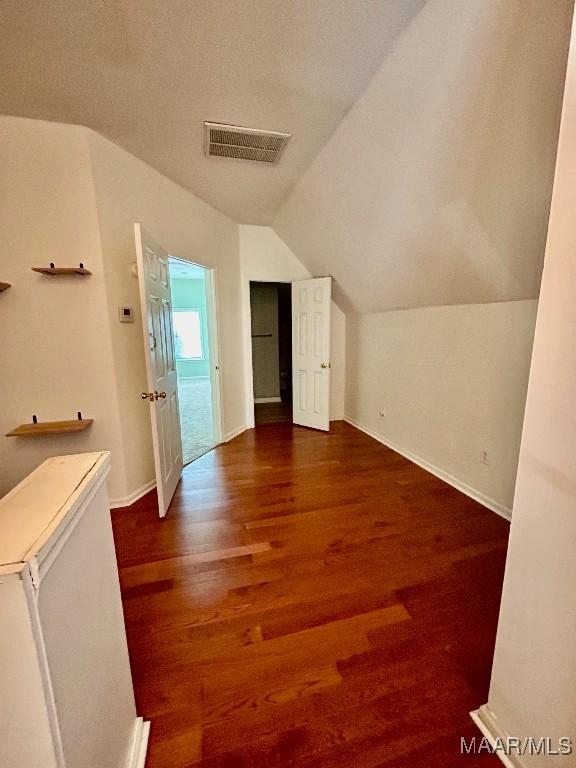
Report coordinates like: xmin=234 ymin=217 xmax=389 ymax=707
xmin=0 ymin=0 xmax=573 ymax=312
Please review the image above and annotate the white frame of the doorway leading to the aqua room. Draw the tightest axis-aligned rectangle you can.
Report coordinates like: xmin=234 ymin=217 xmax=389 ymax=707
xmin=168 ymin=253 xmax=224 ymax=448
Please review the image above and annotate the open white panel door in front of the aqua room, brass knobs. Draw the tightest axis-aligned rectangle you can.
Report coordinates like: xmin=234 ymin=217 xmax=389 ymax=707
xmin=134 ymin=224 xmax=183 ymax=517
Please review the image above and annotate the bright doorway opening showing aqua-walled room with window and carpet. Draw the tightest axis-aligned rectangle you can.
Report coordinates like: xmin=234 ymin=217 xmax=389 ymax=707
xmin=168 ymin=256 xmax=220 ymax=465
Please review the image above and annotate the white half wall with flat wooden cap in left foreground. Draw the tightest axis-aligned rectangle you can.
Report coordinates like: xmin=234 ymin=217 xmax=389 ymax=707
xmin=0 ymin=453 xmax=148 ymax=768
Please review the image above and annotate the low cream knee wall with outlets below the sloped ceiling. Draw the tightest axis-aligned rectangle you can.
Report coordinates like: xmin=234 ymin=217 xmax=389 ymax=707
xmin=346 ymin=301 xmax=536 ymax=513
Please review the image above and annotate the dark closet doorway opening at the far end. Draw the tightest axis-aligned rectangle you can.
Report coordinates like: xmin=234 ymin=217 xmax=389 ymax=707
xmin=250 ymin=281 xmax=292 ymax=427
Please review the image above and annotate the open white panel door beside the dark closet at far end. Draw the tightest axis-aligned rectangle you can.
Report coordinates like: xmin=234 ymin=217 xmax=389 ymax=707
xmin=292 ymin=277 xmax=332 ymax=431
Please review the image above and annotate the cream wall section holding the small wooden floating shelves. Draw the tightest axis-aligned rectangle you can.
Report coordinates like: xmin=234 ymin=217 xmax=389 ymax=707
xmin=0 ymin=117 xmax=125 ymax=495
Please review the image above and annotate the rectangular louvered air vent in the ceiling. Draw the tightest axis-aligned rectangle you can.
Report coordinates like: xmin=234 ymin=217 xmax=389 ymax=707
xmin=204 ymin=123 xmax=291 ymax=164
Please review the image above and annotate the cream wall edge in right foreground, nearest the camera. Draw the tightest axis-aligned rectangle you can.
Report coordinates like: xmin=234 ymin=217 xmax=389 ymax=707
xmin=484 ymin=10 xmax=576 ymax=756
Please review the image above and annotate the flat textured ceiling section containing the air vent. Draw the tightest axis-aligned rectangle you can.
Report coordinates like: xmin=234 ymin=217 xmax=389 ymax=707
xmin=0 ymin=0 xmax=425 ymax=224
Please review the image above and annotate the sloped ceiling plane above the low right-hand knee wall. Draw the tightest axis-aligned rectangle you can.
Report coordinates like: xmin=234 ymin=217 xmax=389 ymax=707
xmin=274 ymin=0 xmax=572 ymax=312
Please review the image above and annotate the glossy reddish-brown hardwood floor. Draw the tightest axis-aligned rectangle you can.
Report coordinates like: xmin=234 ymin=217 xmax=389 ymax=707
xmin=113 ymin=422 xmax=508 ymax=768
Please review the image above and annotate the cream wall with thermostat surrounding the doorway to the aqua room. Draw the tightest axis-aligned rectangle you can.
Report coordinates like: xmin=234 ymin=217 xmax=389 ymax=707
xmin=88 ymin=131 xmax=246 ymax=494
